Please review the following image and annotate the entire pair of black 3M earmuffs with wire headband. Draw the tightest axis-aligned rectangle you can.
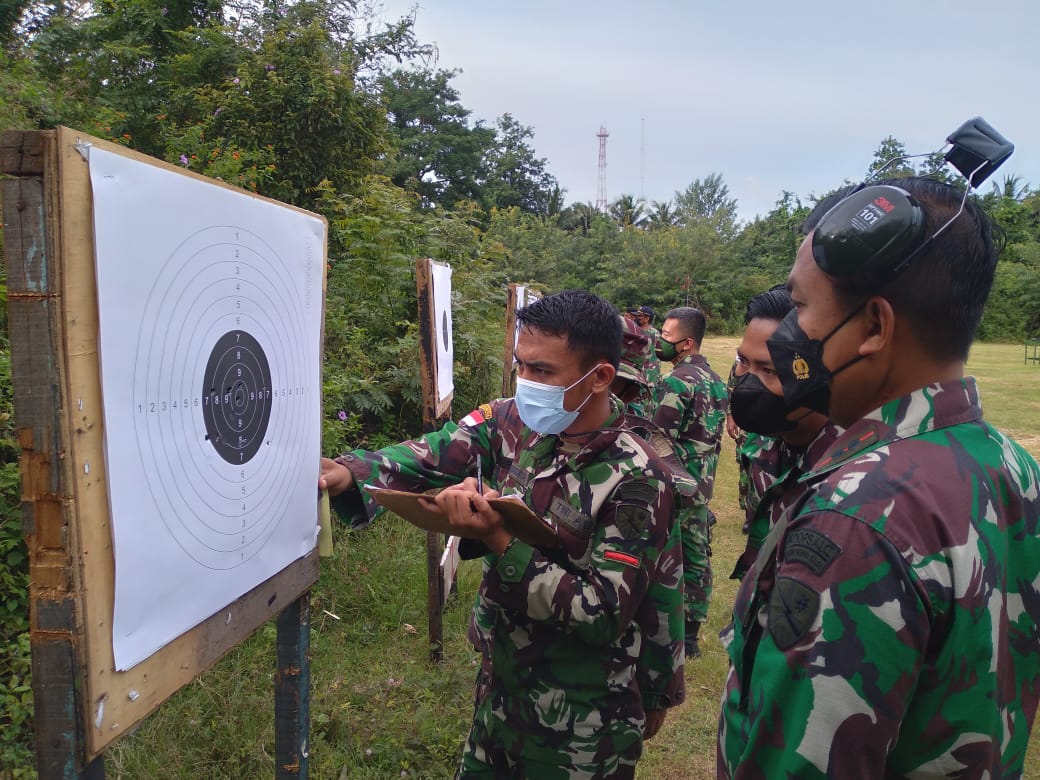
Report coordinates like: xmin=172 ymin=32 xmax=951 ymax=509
xmin=812 ymin=116 xmax=1015 ymax=283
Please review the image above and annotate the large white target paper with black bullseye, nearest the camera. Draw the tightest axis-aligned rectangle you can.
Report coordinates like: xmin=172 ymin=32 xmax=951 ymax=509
xmin=89 ymin=148 xmax=326 ymax=670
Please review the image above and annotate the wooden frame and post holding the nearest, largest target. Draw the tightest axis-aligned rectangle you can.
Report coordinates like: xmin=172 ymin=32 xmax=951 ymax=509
xmin=0 ymin=128 xmax=324 ymax=780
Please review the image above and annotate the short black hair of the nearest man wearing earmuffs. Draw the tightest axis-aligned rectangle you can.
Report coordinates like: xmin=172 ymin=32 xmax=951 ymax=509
xmin=835 ymin=176 xmax=1004 ymax=360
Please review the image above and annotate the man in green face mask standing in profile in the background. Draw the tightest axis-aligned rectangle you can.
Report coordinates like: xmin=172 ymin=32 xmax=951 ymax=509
xmin=653 ymin=307 xmax=727 ymax=658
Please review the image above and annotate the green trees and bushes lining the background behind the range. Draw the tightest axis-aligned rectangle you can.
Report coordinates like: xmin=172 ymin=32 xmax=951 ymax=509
xmin=0 ymin=0 xmax=1040 ymax=777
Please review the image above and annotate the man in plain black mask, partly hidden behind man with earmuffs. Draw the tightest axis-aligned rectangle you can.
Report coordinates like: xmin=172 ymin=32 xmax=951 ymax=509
xmin=729 ymin=285 xmax=839 ymax=579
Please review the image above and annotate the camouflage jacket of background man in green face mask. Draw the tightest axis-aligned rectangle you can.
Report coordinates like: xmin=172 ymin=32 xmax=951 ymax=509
xmin=653 ymin=355 xmax=729 ymax=506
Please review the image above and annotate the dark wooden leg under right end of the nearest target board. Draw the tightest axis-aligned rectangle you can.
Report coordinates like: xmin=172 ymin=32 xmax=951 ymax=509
xmin=275 ymin=593 xmax=311 ymax=780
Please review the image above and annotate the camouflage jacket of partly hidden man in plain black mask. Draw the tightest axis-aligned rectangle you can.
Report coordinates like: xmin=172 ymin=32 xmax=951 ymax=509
xmin=730 ymin=422 xmax=841 ymax=579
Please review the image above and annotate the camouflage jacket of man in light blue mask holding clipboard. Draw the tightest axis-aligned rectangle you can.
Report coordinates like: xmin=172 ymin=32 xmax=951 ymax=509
xmin=336 ymin=398 xmax=685 ymax=756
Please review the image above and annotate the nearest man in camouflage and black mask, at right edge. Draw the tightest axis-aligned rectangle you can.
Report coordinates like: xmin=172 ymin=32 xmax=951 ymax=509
xmin=718 ymin=179 xmax=1040 ymax=778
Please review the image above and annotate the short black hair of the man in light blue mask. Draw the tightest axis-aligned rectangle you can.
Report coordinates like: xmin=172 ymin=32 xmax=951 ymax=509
xmin=517 ymin=290 xmax=621 ymax=368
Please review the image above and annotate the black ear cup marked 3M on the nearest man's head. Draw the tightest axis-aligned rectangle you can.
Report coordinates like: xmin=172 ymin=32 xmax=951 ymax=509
xmin=812 ymin=184 xmax=928 ymax=280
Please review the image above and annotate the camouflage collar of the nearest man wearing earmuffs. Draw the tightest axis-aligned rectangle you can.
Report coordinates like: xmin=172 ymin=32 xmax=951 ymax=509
xmin=799 ymin=376 xmax=982 ymax=482
